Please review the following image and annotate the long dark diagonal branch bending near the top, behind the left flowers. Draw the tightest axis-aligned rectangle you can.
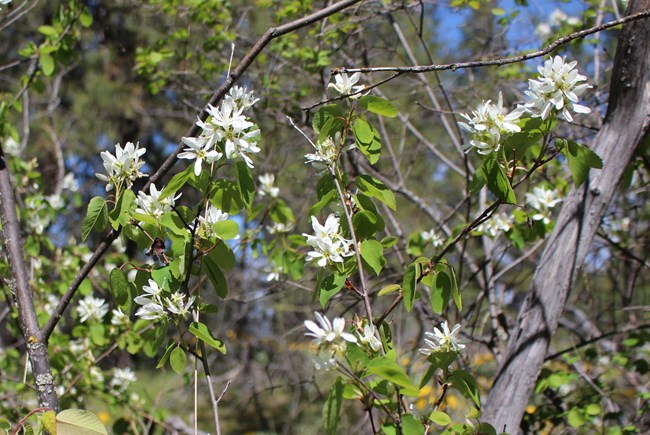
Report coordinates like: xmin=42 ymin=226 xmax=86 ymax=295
xmin=43 ymin=0 xmax=361 ymax=338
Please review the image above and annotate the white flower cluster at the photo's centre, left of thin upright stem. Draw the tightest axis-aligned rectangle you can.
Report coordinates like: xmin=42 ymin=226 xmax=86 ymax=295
xmin=302 ymin=214 xmax=354 ymax=267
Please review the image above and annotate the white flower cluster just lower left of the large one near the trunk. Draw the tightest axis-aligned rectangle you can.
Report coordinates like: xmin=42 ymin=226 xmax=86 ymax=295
xmin=458 ymin=92 xmax=524 ymax=154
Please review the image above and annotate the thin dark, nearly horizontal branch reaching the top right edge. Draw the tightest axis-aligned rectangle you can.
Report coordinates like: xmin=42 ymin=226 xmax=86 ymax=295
xmin=332 ymin=9 xmax=650 ymax=75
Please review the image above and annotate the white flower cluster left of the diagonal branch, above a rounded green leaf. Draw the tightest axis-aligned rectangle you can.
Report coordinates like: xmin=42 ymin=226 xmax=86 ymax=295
xmin=95 ymin=142 xmax=147 ymax=192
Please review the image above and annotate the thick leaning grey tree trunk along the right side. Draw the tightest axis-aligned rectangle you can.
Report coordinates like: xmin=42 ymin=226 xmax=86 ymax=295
xmin=483 ymin=0 xmax=650 ymax=433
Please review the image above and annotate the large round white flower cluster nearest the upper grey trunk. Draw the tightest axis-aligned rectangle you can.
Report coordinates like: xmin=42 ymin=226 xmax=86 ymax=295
xmin=524 ymin=56 xmax=591 ymax=122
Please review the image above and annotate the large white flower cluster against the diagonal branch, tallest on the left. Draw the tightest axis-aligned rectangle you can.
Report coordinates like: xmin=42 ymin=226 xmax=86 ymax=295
xmin=178 ymin=86 xmax=260 ymax=177
